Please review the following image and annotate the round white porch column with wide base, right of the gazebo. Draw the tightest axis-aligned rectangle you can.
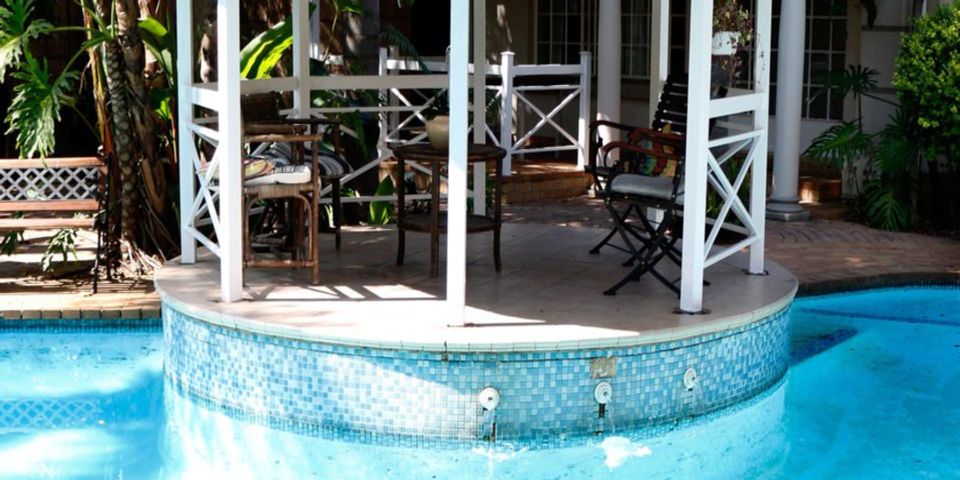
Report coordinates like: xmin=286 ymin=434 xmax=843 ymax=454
xmin=767 ymin=0 xmax=810 ymax=221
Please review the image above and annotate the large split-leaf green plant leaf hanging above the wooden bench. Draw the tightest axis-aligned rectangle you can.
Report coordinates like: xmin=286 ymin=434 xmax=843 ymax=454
xmin=6 ymin=55 xmax=80 ymax=158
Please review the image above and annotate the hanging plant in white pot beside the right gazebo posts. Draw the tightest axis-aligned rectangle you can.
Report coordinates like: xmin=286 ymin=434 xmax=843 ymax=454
xmin=713 ymin=0 xmax=753 ymax=85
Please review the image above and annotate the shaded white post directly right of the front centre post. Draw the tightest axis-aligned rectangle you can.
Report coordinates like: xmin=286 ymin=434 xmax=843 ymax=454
xmin=473 ymin=0 xmax=487 ymax=215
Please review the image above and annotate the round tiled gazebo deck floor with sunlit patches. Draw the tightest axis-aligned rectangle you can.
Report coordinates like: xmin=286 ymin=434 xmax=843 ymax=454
xmin=157 ymin=224 xmax=797 ymax=352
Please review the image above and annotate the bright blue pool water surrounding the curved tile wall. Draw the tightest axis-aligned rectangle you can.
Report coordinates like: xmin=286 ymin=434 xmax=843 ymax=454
xmin=0 ymin=288 xmax=960 ymax=480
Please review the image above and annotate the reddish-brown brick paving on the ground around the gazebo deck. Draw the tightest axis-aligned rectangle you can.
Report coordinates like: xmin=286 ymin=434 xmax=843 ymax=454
xmin=0 ymin=197 xmax=960 ymax=320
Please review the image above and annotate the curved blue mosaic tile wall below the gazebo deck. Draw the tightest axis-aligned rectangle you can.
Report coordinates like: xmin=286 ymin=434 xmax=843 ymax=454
xmin=163 ymin=306 xmax=789 ymax=444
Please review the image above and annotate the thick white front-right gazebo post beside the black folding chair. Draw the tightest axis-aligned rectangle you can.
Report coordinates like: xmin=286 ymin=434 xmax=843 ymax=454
xmin=680 ymin=0 xmax=713 ymax=313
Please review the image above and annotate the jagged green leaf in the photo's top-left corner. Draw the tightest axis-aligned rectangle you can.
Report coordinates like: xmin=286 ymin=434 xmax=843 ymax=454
xmin=0 ymin=0 xmax=53 ymax=82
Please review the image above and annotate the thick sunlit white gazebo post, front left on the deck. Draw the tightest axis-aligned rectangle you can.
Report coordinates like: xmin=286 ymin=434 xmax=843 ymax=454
xmin=217 ymin=0 xmax=243 ymax=302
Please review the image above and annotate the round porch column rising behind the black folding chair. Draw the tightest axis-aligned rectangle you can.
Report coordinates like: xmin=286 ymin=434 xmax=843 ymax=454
xmin=597 ymin=0 xmax=622 ymax=148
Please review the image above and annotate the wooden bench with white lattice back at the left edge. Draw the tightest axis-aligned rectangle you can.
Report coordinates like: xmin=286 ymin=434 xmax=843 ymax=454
xmin=0 ymin=157 xmax=109 ymax=293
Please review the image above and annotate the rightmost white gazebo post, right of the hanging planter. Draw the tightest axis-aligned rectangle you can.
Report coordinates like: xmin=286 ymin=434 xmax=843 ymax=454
xmin=750 ymin=0 xmax=772 ymax=275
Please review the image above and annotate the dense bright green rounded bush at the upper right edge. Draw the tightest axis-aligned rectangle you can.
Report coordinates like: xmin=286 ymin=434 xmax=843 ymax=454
xmin=893 ymin=3 xmax=960 ymax=161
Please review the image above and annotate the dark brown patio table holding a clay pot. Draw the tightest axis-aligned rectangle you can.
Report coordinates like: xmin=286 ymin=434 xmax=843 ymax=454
xmin=393 ymin=145 xmax=507 ymax=277
